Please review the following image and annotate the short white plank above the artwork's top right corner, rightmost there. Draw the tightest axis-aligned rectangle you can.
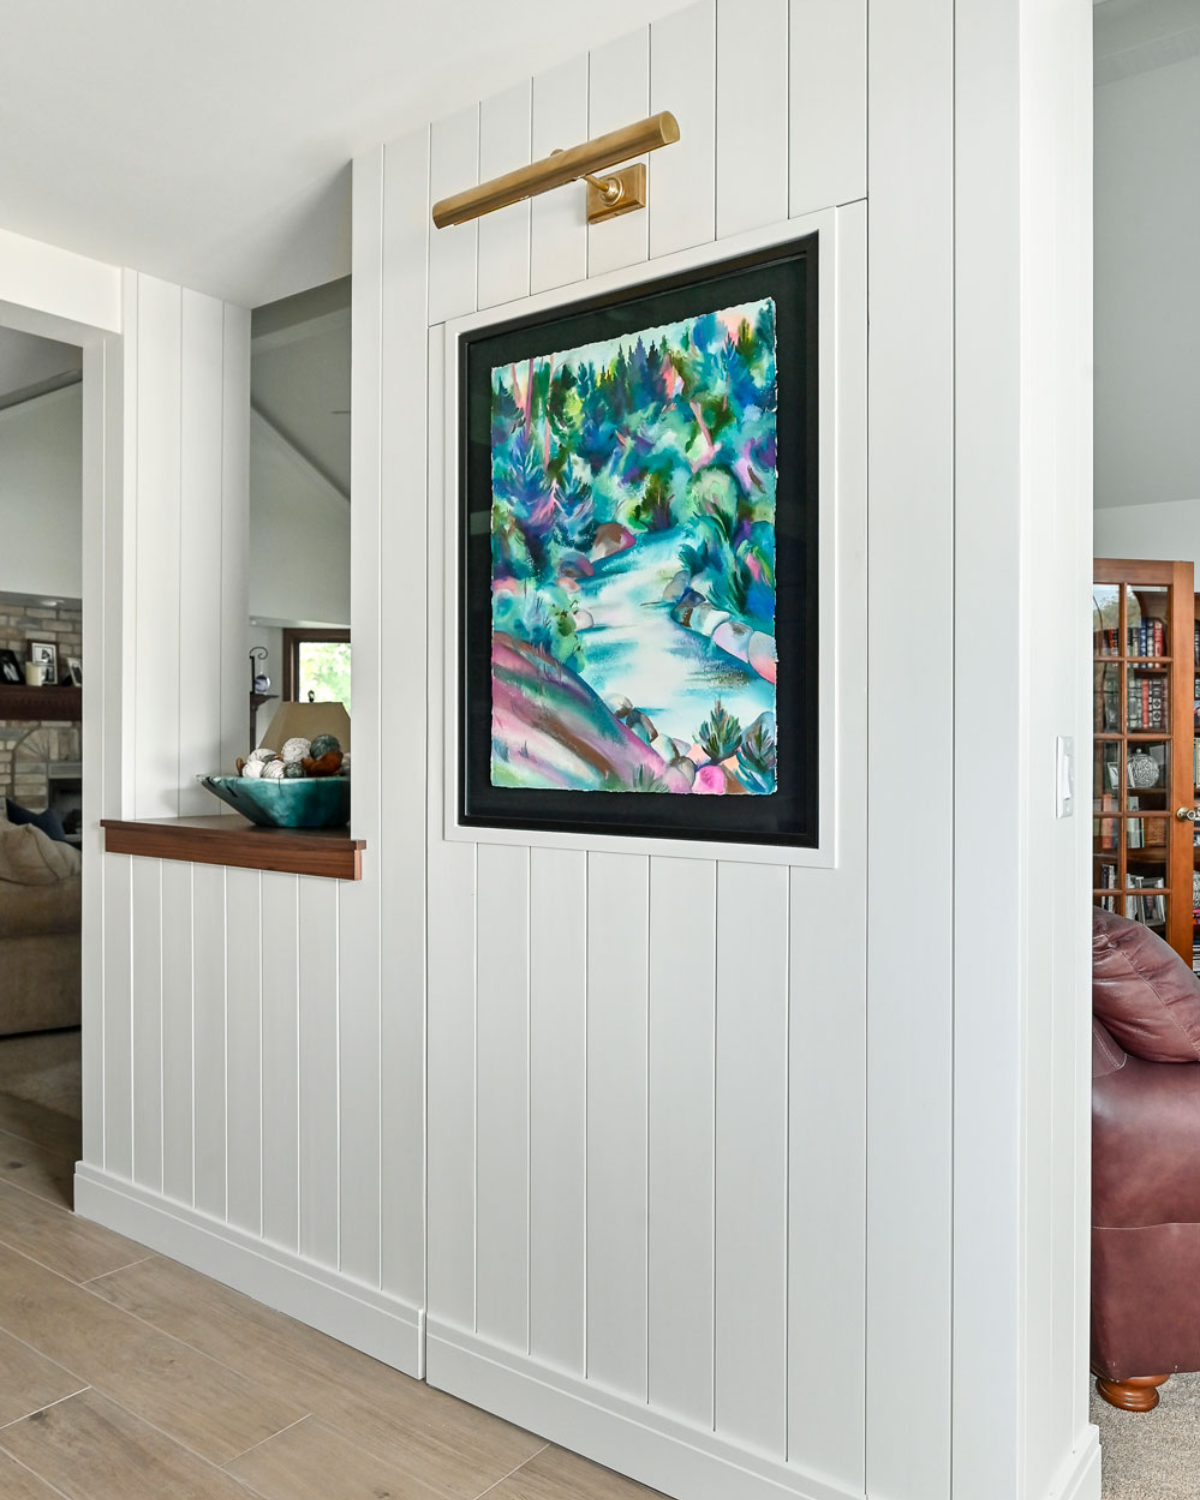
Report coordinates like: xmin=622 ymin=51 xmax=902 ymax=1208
xmin=788 ymin=0 xmax=867 ymax=216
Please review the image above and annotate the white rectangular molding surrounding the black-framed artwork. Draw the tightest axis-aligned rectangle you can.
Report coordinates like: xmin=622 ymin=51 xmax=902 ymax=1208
xmin=443 ymin=209 xmax=846 ymax=869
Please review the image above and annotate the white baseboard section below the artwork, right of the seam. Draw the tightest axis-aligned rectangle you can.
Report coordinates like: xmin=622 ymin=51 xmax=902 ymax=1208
xmin=426 ymin=1319 xmax=864 ymax=1500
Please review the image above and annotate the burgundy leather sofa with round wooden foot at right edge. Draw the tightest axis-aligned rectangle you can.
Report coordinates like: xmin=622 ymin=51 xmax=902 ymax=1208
xmin=1092 ymin=909 xmax=1200 ymax=1412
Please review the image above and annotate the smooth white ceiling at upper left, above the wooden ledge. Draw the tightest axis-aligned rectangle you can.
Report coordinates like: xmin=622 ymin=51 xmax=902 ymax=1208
xmin=0 ymin=0 xmax=681 ymax=306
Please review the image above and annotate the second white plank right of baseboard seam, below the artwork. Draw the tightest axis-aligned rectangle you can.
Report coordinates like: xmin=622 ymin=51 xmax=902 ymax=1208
xmin=476 ymin=845 xmax=530 ymax=1353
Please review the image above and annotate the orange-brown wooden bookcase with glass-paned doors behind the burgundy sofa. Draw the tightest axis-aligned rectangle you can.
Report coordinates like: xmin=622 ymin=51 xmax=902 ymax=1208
xmin=1092 ymin=558 xmax=1197 ymax=965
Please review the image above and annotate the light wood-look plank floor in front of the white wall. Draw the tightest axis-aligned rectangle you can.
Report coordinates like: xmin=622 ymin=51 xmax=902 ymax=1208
xmin=0 ymin=1041 xmax=654 ymax=1500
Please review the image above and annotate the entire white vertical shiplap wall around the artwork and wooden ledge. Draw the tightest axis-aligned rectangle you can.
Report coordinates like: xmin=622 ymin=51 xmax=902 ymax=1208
xmin=70 ymin=0 xmax=1097 ymax=1500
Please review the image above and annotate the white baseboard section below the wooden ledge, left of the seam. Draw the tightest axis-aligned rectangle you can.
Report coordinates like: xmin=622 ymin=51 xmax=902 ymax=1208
xmin=75 ymin=1163 xmax=425 ymax=1379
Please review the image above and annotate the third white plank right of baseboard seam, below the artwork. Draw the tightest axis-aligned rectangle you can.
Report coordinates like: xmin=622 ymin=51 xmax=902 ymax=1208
xmin=530 ymin=849 xmax=588 ymax=1376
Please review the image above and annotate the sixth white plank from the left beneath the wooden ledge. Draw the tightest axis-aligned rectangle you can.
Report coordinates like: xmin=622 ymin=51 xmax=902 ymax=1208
xmin=263 ymin=873 xmax=300 ymax=1250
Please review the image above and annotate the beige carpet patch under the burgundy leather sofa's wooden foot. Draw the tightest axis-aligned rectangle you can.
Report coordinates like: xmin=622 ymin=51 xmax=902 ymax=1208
xmin=1092 ymin=1376 xmax=1200 ymax=1500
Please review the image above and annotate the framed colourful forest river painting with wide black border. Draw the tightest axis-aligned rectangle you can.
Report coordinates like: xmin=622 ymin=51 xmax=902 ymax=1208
xmin=452 ymin=234 xmax=822 ymax=849
